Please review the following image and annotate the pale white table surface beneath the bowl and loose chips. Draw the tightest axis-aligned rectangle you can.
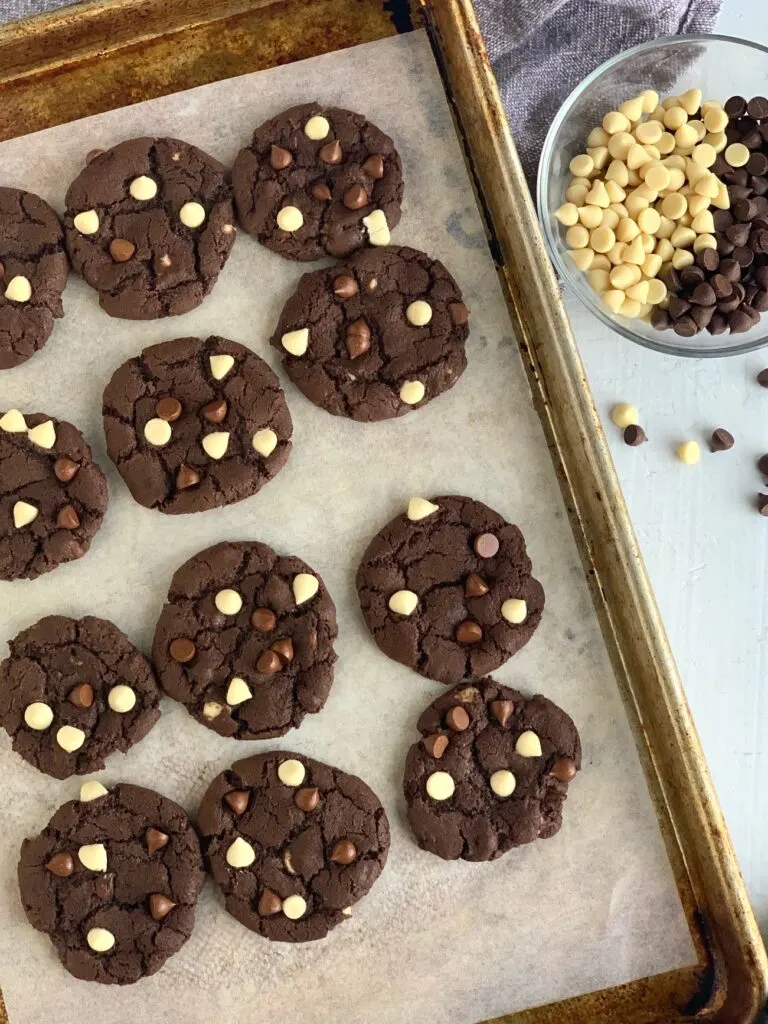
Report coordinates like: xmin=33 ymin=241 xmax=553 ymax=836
xmin=567 ymin=0 xmax=768 ymax=938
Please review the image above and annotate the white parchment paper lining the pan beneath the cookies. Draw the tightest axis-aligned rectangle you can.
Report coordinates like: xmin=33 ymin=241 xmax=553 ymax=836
xmin=0 ymin=33 xmax=694 ymax=1024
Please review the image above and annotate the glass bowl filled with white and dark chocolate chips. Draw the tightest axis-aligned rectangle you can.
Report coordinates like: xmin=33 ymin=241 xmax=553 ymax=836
xmin=538 ymin=36 xmax=768 ymax=357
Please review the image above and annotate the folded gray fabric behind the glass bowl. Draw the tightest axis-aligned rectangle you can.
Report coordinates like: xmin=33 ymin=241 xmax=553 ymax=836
xmin=474 ymin=0 xmax=720 ymax=186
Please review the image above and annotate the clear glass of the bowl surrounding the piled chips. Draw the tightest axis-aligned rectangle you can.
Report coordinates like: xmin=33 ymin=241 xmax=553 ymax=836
xmin=537 ymin=36 xmax=768 ymax=357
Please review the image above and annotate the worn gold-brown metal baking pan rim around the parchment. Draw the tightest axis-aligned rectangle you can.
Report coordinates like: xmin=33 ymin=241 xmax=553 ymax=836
xmin=0 ymin=0 xmax=768 ymax=1024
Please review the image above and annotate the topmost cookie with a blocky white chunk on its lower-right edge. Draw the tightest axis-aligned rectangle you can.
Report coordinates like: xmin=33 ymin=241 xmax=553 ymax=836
xmin=232 ymin=102 xmax=402 ymax=260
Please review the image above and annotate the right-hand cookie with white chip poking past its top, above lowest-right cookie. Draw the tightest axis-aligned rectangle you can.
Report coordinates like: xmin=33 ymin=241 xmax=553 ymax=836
xmin=357 ymin=496 xmax=544 ymax=683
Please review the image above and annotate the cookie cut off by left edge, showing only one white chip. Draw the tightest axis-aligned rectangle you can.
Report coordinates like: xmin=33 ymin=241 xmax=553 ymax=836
xmin=0 ymin=188 xmax=70 ymax=370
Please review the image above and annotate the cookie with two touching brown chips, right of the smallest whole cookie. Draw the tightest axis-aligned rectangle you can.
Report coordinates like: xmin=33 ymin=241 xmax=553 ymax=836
xmin=153 ymin=541 xmax=338 ymax=739
